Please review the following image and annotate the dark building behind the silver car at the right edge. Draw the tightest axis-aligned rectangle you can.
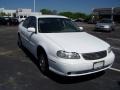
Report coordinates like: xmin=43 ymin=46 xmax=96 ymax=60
xmin=92 ymin=7 xmax=120 ymax=22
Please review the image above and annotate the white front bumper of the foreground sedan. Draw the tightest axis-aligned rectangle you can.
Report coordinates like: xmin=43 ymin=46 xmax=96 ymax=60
xmin=49 ymin=52 xmax=115 ymax=76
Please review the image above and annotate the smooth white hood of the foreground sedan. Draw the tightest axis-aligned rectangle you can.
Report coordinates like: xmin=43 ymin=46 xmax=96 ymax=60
xmin=46 ymin=32 xmax=109 ymax=53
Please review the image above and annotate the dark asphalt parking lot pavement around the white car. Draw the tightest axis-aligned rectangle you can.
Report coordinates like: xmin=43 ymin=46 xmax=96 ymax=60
xmin=0 ymin=24 xmax=120 ymax=90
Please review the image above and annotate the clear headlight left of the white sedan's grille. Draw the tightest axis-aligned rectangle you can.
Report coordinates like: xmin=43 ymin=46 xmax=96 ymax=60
xmin=57 ymin=50 xmax=80 ymax=59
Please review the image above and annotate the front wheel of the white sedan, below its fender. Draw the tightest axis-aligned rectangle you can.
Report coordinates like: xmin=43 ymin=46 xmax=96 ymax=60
xmin=38 ymin=50 xmax=49 ymax=74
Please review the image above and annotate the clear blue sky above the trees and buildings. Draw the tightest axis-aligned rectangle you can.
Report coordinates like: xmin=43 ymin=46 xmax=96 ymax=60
xmin=0 ymin=0 xmax=120 ymax=13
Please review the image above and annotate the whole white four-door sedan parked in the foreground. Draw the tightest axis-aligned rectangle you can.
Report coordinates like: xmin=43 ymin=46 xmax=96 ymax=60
xmin=18 ymin=15 xmax=115 ymax=76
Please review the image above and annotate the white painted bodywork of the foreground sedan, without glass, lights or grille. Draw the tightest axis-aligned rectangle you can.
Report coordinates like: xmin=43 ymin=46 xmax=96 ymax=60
xmin=18 ymin=15 xmax=115 ymax=76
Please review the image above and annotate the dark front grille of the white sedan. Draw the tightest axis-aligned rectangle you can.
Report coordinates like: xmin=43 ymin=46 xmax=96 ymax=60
xmin=82 ymin=51 xmax=107 ymax=60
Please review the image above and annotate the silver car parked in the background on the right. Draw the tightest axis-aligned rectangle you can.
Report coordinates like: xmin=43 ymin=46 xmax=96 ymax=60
xmin=95 ymin=19 xmax=115 ymax=32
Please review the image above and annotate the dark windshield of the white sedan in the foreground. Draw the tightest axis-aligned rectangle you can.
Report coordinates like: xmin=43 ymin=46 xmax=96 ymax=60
xmin=38 ymin=18 xmax=80 ymax=33
